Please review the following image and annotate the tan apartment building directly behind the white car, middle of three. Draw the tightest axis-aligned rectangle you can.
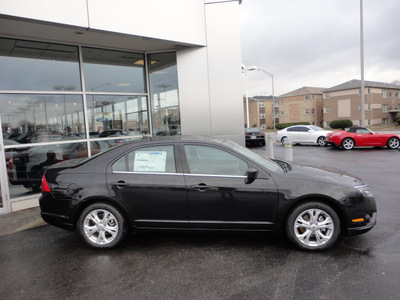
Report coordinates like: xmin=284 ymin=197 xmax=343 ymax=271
xmin=278 ymin=87 xmax=324 ymax=126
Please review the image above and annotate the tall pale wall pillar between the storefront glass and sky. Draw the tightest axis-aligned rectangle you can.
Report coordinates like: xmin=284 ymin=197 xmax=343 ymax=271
xmin=177 ymin=2 xmax=244 ymax=145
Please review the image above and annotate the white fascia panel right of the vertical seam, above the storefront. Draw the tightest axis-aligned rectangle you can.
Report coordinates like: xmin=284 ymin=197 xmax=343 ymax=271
xmin=87 ymin=0 xmax=206 ymax=45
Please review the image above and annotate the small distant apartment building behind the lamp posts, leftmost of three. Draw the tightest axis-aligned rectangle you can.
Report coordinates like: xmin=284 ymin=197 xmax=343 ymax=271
xmin=243 ymin=96 xmax=279 ymax=129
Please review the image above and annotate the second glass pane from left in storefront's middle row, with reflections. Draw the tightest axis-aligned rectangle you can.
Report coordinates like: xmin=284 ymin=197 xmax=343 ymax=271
xmin=87 ymin=95 xmax=148 ymax=138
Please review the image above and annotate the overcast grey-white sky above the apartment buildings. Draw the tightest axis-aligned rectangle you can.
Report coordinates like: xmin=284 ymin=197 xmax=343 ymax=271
xmin=240 ymin=0 xmax=400 ymax=96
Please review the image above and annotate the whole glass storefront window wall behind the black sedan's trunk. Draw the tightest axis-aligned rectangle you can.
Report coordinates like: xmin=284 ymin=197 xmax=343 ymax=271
xmin=0 ymin=38 xmax=181 ymax=208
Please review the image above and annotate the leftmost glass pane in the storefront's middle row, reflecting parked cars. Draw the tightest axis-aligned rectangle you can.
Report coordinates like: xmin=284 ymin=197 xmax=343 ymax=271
xmin=0 ymin=94 xmax=85 ymax=144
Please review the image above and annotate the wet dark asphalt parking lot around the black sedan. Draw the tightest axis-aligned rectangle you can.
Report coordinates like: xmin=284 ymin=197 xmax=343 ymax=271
xmin=0 ymin=144 xmax=400 ymax=299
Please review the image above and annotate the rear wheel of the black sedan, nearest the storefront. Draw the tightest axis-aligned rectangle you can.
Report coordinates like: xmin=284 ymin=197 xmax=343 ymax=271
xmin=78 ymin=202 xmax=126 ymax=249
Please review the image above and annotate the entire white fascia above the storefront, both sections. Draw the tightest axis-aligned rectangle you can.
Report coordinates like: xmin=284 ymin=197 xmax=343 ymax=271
xmin=0 ymin=0 xmax=206 ymax=46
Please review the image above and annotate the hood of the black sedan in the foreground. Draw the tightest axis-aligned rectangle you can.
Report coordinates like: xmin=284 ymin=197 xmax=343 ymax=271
xmin=287 ymin=163 xmax=366 ymax=186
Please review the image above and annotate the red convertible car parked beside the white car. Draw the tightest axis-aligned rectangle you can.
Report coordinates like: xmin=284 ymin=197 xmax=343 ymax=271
xmin=326 ymin=127 xmax=400 ymax=150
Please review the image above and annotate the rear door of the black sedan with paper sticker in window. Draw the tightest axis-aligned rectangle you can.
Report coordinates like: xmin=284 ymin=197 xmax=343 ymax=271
xmin=107 ymin=144 xmax=188 ymax=228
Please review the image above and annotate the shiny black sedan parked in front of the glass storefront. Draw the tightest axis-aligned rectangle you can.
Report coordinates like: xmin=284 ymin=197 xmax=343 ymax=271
xmin=40 ymin=137 xmax=376 ymax=250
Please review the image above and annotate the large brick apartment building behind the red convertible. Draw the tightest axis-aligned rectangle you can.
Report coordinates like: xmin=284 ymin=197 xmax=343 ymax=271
xmin=323 ymin=79 xmax=400 ymax=127
